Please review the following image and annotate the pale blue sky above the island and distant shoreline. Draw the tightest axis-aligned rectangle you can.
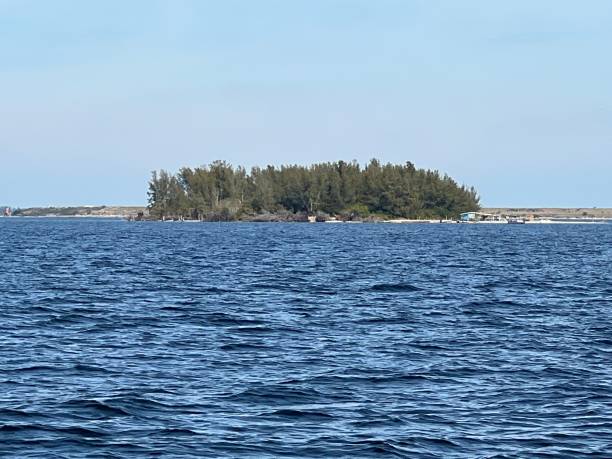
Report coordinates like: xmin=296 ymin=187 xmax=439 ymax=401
xmin=0 ymin=0 xmax=612 ymax=207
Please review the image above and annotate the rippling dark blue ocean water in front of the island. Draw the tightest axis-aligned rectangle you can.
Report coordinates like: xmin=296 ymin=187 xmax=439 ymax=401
xmin=0 ymin=218 xmax=612 ymax=458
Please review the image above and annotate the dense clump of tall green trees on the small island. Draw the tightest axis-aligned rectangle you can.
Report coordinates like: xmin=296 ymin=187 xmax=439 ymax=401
xmin=148 ymin=159 xmax=480 ymax=220
